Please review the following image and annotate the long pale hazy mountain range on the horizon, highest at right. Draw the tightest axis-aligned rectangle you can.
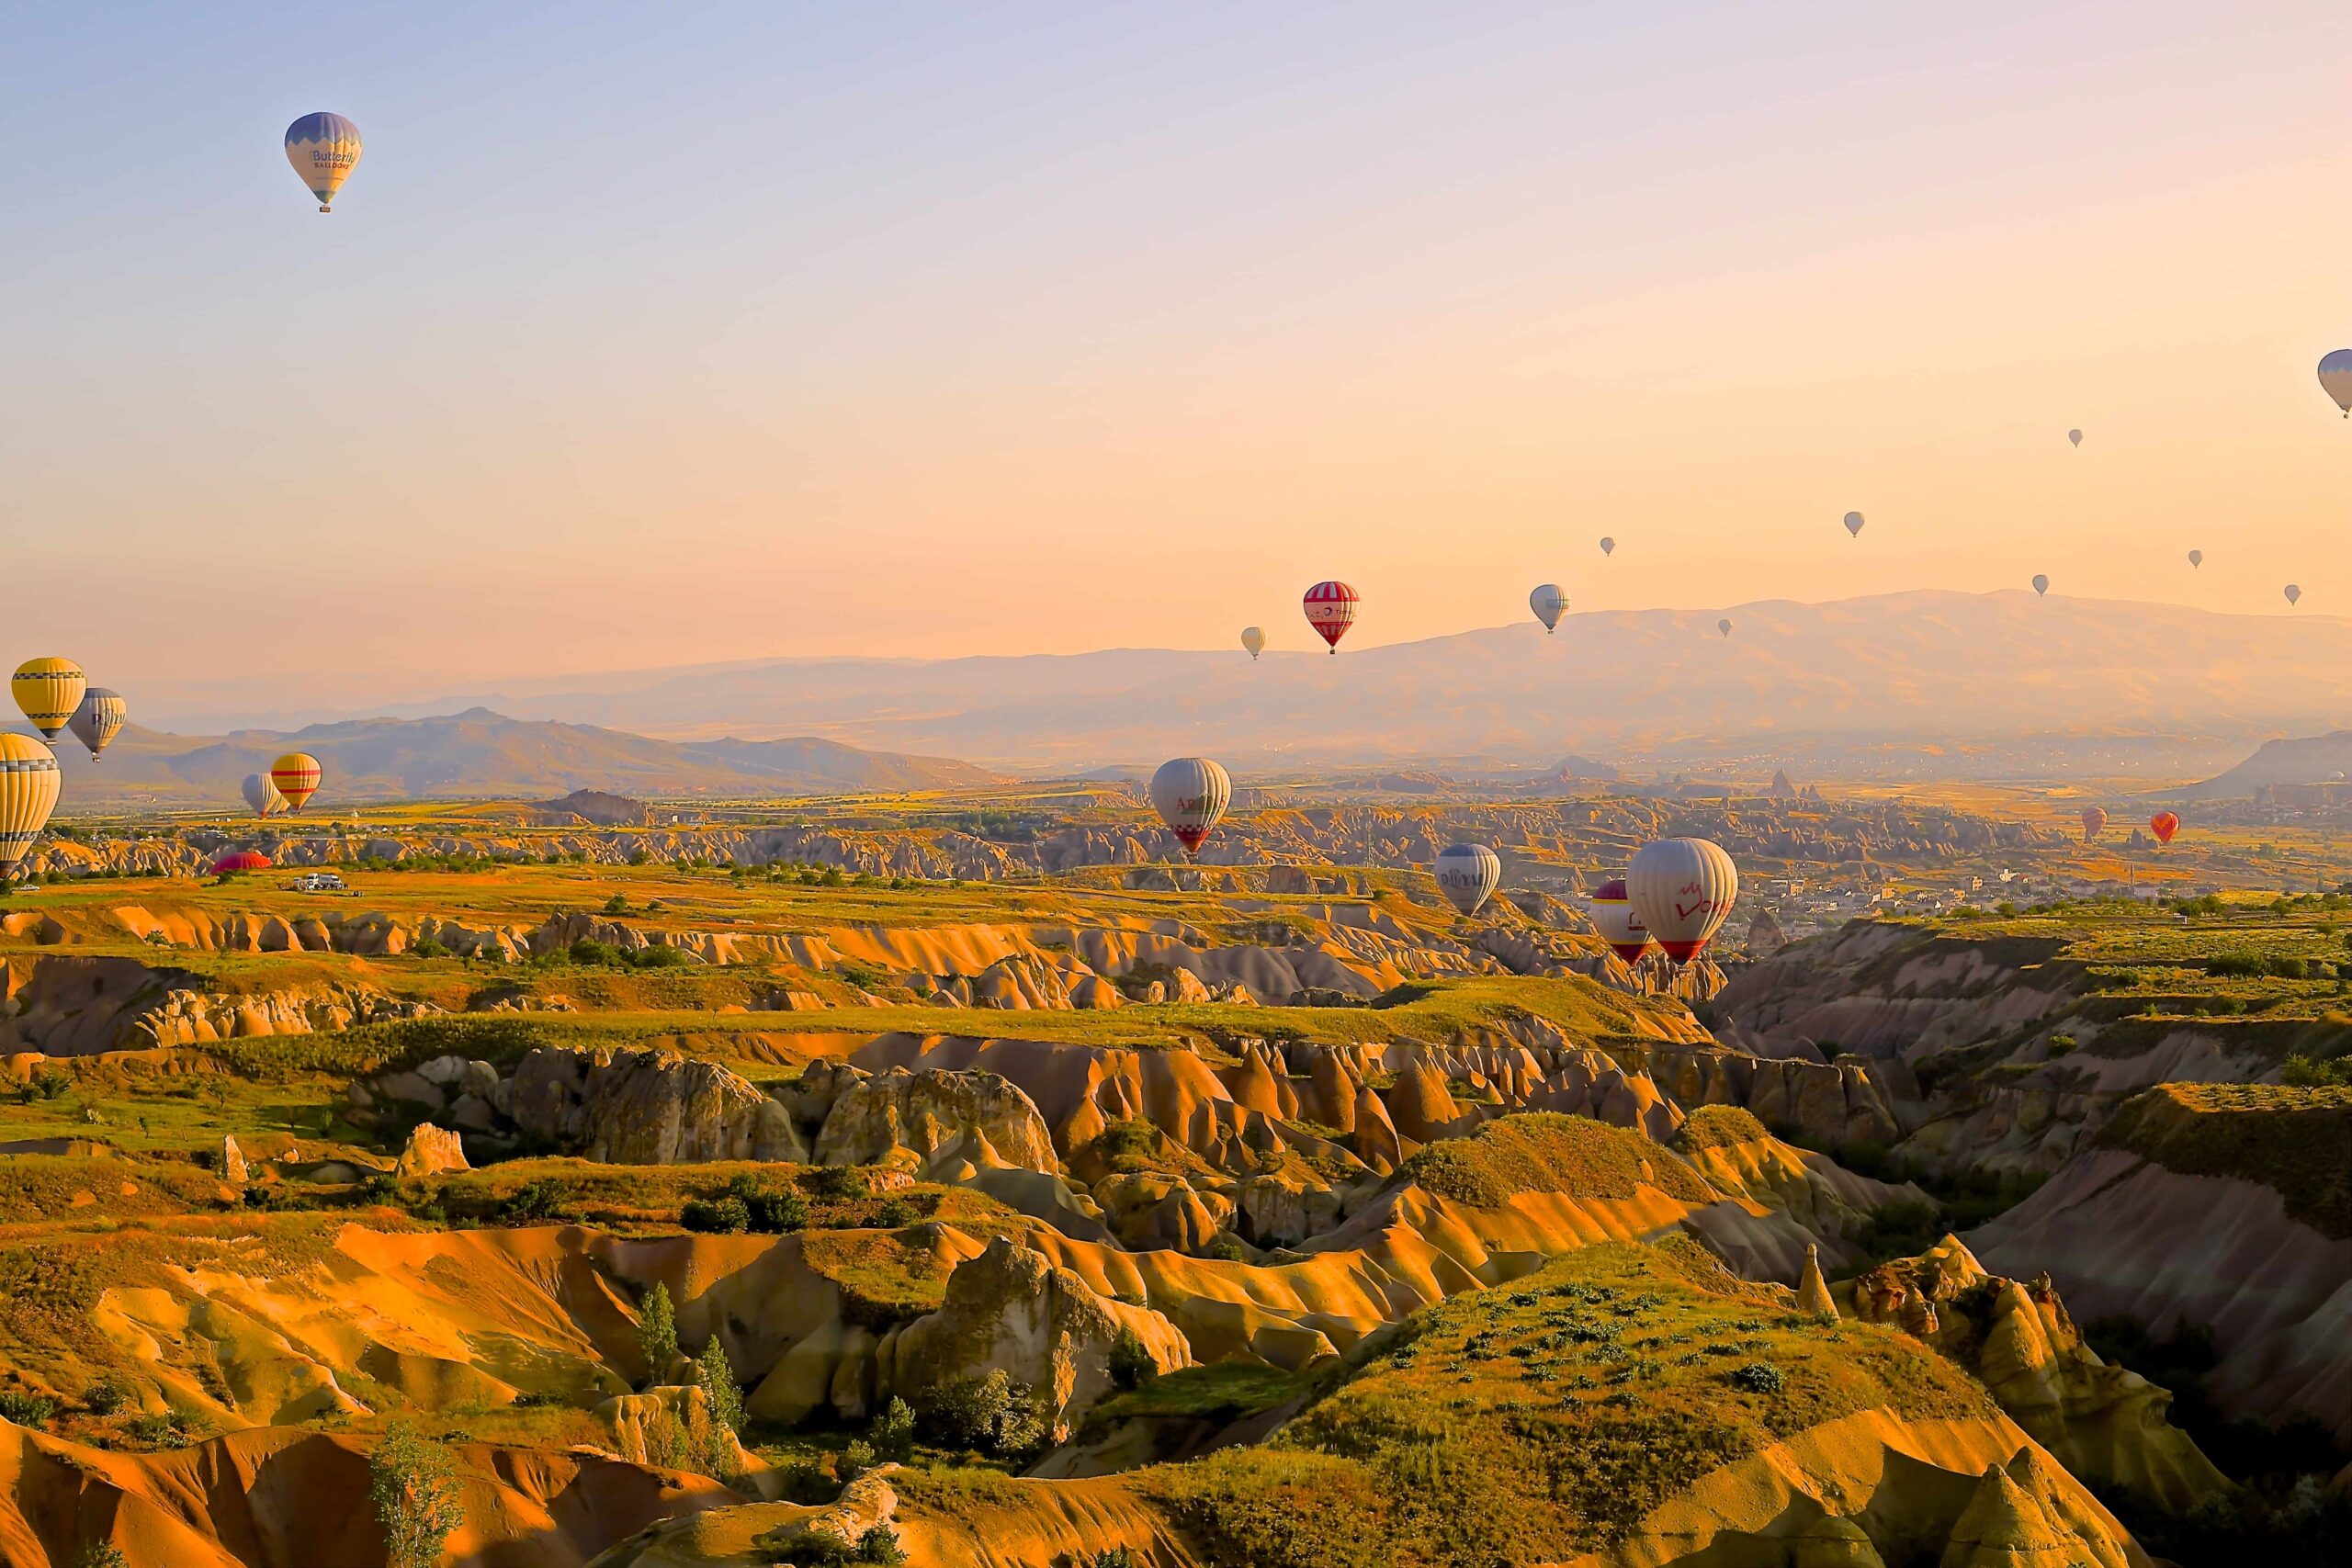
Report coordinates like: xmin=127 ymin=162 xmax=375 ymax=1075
xmin=275 ymin=590 xmax=2352 ymax=773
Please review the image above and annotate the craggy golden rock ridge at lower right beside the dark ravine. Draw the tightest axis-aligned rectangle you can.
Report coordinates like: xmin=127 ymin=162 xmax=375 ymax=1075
xmin=1835 ymin=1236 xmax=2230 ymax=1512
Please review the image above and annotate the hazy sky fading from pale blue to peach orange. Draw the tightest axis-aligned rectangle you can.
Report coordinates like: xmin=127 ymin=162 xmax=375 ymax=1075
xmin=0 ymin=0 xmax=2352 ymax=701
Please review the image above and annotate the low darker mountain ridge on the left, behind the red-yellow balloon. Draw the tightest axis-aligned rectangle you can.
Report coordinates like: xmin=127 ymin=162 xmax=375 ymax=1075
xmin=56 ymin=707 xmax=1002 ymax=811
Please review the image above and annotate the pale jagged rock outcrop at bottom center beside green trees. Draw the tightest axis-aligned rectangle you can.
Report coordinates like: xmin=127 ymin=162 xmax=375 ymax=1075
xmin=882 ymin=1236 xmax=1193 ymax=1443
